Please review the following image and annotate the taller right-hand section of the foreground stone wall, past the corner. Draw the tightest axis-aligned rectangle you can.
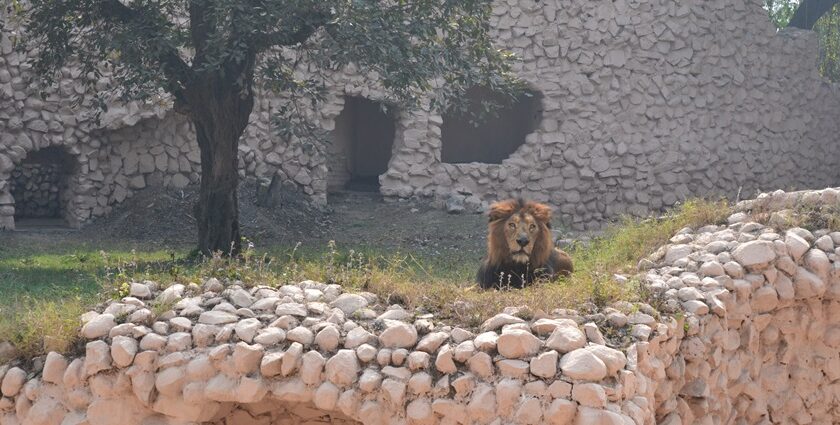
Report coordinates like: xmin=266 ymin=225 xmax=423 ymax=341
xmin=639 ymin=188 xmax=840 ymax=424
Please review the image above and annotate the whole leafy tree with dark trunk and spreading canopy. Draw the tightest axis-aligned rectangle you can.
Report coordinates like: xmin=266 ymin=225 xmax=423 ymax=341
xmin=15 ymin=0 xmax=516 ymax=254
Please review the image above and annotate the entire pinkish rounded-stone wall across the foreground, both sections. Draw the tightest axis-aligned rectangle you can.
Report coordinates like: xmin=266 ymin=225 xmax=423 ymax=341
xmin=0 ymin=188 xmax=840 ymax=425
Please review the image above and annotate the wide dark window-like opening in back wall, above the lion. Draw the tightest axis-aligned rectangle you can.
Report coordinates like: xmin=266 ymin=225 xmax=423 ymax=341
xmin=441 ymin=87 xmax=542 ymax=164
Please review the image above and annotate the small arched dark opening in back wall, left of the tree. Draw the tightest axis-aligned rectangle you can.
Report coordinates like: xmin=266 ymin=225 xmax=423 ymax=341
xmin=11 ymin=147 xmax=76 ymax=227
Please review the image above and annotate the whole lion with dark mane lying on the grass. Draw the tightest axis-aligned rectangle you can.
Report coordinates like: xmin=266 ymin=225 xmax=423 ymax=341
xmin=476 ymin=199 xmax=573 ymax=289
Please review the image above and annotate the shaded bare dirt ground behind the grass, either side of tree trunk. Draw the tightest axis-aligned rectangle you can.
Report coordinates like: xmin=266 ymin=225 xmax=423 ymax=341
xmin=0 ymin=183 xmax=496 ymax=258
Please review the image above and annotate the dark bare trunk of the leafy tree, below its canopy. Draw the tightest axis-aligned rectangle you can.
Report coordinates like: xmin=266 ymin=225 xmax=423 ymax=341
xmin=187 ymin=64 xmax=254 ymax=256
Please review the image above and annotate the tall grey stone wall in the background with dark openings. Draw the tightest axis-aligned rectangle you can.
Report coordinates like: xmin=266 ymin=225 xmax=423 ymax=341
xmin=0 ymin=0 xmax=840 ymax=229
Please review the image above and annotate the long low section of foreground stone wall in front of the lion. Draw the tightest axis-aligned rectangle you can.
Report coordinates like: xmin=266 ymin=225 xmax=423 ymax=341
xmin=0 ymin=278 xmax=678 ymax=425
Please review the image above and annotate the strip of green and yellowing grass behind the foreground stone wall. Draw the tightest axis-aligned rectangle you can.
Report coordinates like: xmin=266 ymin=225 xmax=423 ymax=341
xmin=0 ymin=197 xmax=729 ymax=357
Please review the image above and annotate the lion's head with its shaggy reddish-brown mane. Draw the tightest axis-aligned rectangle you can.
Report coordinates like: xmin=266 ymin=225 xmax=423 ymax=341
xmin=487 ymin=199 xmax=553 ymax=265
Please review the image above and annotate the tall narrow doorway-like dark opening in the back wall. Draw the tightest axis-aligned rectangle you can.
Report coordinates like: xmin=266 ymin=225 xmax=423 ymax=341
xmin=327 ymin=96 xmax=396 ymax=192
